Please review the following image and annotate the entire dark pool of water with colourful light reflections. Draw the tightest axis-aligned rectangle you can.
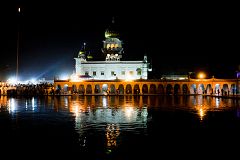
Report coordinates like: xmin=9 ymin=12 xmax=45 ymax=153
xmin=0 ymin=96 xmax=240 ymax=160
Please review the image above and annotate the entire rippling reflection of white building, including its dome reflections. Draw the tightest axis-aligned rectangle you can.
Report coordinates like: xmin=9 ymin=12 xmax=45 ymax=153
xmin=66 ymin=96 xmax=148 ymax=154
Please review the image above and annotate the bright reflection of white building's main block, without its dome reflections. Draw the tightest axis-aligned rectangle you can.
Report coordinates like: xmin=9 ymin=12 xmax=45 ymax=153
xmin=69 ymin=96 xmax=147 ymax=124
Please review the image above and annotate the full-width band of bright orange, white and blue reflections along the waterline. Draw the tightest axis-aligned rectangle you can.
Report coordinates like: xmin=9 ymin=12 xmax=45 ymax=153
xmin=0 ymin=96 xmax=239 ymax=126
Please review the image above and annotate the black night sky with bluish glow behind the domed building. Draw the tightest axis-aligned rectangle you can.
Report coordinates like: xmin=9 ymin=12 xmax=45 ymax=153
xmin=0 ymin=0 xmax=240 ymax=80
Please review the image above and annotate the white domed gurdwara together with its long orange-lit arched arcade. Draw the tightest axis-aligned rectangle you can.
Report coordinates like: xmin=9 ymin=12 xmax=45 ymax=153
xmin=53 ymin=21 xmax=239 ymax=95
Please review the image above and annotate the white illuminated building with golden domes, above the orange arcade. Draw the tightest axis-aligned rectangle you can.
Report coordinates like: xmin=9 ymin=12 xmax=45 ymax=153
xmin=72 ymin=18 xmax=151 ymax=80
